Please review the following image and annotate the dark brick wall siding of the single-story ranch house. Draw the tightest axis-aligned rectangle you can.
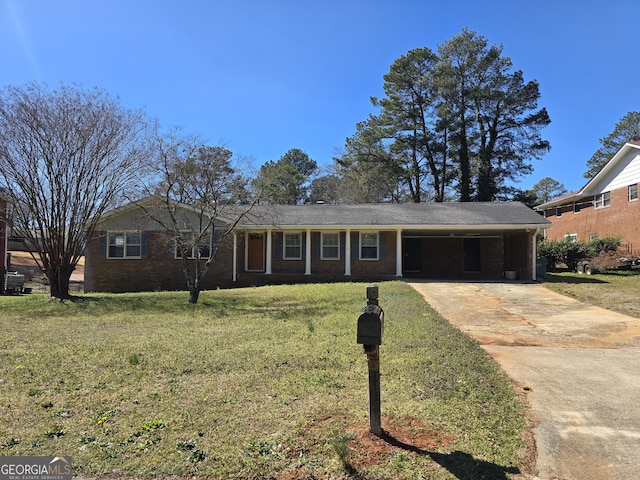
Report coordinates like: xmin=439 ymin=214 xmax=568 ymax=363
xmin=85 ymin=231 xmax=535 ymax=293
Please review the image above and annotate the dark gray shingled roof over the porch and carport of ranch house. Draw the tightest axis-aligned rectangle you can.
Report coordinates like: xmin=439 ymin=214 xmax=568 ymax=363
xmin=240 ymin=202 xmax=550 ymax=227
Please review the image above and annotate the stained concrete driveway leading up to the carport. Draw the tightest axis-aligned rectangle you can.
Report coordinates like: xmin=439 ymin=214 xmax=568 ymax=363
xmin=409 ymin=281 xmax=640 ymax=480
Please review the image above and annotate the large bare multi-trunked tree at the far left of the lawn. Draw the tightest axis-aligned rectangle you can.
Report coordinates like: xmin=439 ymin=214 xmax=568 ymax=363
xmin=0 ymin=83 xmax=145 ymax=299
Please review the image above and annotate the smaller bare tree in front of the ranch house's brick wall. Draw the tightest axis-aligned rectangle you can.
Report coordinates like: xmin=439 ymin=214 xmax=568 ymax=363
xmin=137 ymin=125 xmax=255 ymax=303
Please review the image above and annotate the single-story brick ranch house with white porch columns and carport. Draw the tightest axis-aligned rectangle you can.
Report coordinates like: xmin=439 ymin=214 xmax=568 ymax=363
xmin=85 ymin=202 xmax=549 ymax=292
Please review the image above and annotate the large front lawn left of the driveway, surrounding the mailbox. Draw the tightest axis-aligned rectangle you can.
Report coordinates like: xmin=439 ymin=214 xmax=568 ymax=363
xmin=0 ymin=282 xmax=532 ymax=479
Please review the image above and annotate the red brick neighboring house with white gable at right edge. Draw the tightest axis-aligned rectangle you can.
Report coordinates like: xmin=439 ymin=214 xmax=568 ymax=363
xmin=535 ymin=142 xmax=640 ymax=253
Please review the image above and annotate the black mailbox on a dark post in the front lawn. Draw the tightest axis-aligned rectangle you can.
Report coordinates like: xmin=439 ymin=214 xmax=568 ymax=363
xmin=357 ymin=284 xmax=384 ymax=437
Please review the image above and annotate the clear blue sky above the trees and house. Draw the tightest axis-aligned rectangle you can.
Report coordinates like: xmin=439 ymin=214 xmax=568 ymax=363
xmin=0 ymin=0 xmax=640 ymax=194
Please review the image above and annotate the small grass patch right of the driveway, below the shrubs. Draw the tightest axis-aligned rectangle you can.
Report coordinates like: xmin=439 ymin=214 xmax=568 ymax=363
xmin=545 ymin=270 xmax=640 ymax=318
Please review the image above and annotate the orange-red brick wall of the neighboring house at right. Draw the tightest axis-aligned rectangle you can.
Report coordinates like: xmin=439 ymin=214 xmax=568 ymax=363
xmin=545 ymin=187 xmax=640 ymax=252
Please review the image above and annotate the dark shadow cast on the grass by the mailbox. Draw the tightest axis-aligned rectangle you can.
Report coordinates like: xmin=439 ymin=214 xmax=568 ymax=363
xmin=382 ymin=431 xmax=520 ymax=480
